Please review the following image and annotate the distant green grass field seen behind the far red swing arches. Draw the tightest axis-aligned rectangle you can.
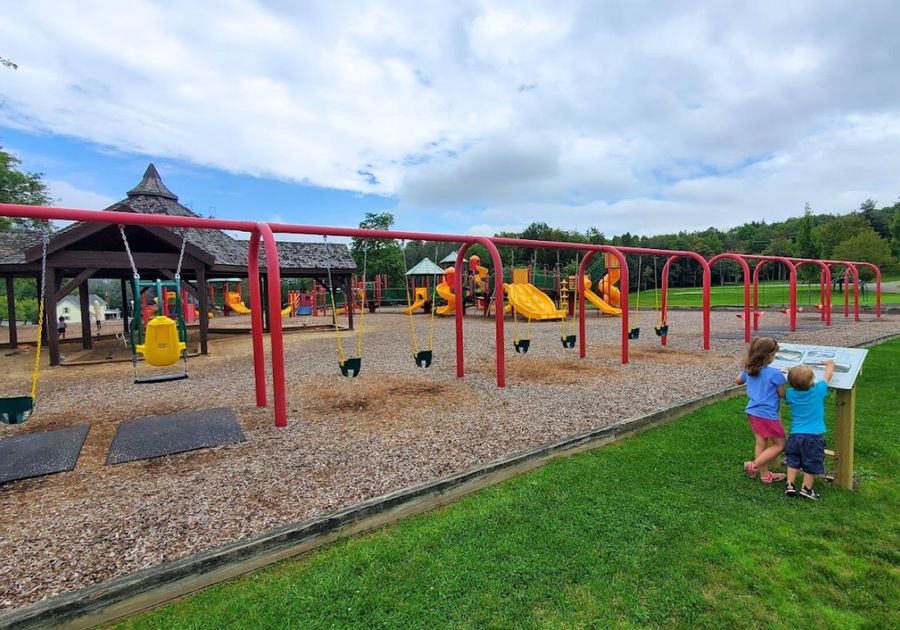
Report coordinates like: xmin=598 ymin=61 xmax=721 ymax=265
xmin=628 ymin=282 xmax=900 ymax=309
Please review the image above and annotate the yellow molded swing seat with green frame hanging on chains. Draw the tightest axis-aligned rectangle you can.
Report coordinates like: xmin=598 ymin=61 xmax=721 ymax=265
xmin=119 ymin=225 xmax=188 ymax=385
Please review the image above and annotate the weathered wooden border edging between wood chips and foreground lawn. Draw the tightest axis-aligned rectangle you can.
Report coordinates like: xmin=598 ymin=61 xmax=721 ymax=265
xmin=0 ymin=333 xmax=900 ymax=628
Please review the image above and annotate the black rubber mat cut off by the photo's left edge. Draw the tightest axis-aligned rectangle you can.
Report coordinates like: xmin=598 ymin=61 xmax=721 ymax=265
xmin=0 ymin=424 xmax=91 ymax=483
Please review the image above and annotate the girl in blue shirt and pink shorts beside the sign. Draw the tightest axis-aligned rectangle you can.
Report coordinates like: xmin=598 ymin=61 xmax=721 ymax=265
xmin=735 ymin=337 xmax=787 ymax=483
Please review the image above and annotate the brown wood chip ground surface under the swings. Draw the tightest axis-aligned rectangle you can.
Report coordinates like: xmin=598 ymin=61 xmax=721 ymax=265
xmin=0 ymin=311 xmax=900 ymax=609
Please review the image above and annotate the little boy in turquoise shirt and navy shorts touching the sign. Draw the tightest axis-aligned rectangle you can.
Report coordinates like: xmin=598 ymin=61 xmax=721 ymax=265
xmin=784 ymin=359 xmax=834 ymax=500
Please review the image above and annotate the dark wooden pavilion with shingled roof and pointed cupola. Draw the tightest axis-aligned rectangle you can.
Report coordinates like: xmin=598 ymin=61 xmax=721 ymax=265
xmin=0 ymin=164 xmax=356 ymax=365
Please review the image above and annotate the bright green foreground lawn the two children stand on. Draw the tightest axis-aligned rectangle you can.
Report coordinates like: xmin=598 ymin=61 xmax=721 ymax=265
xmin=123 ymin=341 xmax=900 ymax=628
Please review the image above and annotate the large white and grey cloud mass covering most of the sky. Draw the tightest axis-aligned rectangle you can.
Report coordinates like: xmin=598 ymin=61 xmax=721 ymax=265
xmin=0 ymin=0 xmax=900 ymax=233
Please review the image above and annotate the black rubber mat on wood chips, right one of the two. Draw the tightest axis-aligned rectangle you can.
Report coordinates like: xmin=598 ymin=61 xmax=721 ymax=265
xmin=106 ymin=407 xmax=246 ymax=465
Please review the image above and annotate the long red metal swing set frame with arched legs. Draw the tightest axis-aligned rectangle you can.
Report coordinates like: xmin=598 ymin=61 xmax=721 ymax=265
xmin=0 ymin=204 xmax=881 ymax=427
